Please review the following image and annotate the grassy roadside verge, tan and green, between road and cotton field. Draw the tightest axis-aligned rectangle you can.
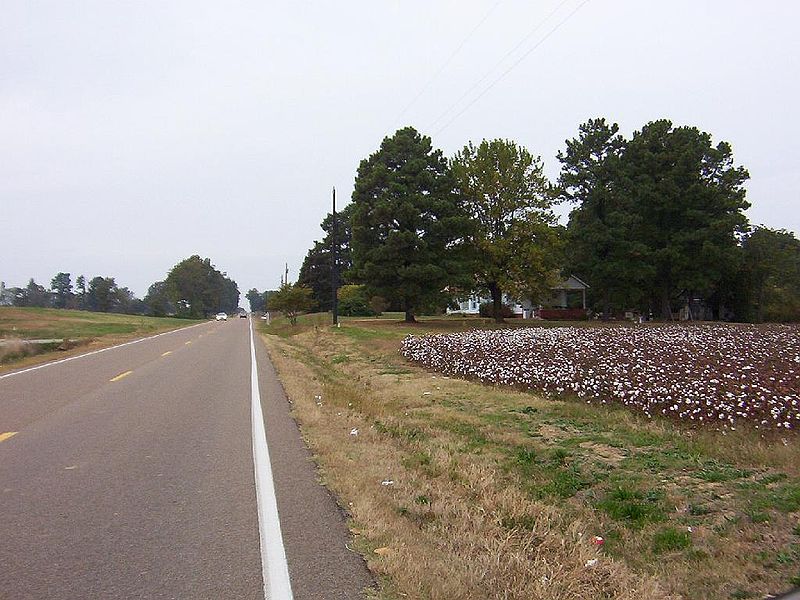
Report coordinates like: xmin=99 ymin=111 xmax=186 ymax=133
xmin=266 ymin=322 xmax=800 ymax=600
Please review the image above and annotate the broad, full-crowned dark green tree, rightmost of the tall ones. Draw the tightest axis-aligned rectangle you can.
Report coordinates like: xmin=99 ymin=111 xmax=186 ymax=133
xmin=624 ymin=120 xmax=750 ymax=319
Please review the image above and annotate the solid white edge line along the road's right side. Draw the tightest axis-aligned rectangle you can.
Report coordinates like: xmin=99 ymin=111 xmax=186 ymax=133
xmin=250 ymin=320 xmax=292 ymax=600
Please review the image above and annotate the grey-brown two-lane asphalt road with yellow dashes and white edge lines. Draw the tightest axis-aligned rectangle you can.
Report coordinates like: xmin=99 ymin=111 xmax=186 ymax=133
xmin=0 ymin=319 xmax=371 ymax=600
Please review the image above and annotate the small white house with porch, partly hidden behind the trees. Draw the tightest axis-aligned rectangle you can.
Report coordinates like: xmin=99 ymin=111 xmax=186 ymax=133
xmin=447 ymin=275 xmax=589 ymax=319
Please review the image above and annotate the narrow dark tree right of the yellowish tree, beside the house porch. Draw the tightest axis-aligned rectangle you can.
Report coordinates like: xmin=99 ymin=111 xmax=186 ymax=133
xmin=558 ymin=119 xmax=652 ymax=317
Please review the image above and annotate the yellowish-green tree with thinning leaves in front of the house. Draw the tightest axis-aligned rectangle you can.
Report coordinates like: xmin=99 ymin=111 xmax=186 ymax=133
xmin=451 ymin=139 xmax=560 ymax=323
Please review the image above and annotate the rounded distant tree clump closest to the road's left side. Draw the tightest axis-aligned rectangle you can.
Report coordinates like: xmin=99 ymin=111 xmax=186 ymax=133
xmin=164 ymin=254 xmax=239 ymax=319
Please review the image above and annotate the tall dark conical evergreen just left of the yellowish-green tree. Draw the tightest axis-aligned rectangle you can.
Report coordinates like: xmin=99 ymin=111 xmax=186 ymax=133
xmin=351 ymin=127 xmax=469 ymax=322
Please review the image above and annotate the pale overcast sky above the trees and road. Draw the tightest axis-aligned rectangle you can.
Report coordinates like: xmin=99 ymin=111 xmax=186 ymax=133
xmin=0 ymin=0 xmax=800 ymax=305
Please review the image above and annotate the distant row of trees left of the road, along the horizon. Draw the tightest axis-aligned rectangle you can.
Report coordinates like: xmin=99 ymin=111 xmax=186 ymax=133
xmin=0 ymin=255 xmax=239 ymax=318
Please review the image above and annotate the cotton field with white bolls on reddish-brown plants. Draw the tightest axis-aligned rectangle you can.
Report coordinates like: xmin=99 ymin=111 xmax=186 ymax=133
xmin=402 ymin=324 xmax=800 ymax=430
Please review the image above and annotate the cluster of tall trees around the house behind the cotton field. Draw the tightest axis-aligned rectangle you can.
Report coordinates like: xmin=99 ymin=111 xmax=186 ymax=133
xmin=295 ymin=119 xmax=800 ymax=322
